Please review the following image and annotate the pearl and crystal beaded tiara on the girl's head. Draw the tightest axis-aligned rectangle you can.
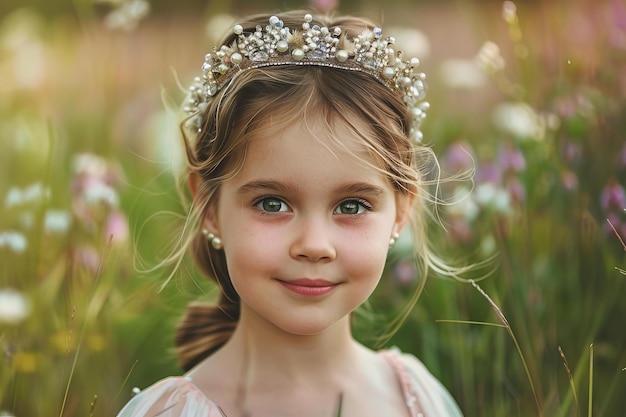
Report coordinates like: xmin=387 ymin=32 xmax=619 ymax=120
xmin=184 ymin=14 xmax=429 ymax=142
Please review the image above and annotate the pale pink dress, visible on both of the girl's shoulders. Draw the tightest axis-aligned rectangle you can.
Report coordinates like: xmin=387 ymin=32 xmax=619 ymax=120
xmin=117 ymin=349 xmax=462 ymax=417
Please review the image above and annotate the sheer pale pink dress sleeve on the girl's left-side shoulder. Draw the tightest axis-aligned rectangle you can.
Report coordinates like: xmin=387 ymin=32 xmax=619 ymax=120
xmin=117 ymin=377 xmax=224 ymax=417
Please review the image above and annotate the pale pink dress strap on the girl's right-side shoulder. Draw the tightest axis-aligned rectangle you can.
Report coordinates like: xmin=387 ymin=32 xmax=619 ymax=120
xmin=380 ymin=348 xmax=462 ymax=417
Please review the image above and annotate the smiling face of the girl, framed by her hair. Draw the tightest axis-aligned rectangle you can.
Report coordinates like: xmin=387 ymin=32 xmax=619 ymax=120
xmin=204 ymin=114 xmax=412 ymax=335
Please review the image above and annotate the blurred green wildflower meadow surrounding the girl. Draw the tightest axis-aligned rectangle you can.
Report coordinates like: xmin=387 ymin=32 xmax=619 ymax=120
xmin=0 ymin=0 xmax=626 ymax=417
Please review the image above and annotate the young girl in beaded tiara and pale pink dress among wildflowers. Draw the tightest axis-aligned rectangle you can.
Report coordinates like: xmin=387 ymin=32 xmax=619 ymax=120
xmin=119 ymin=12 xmax=461 ymax=417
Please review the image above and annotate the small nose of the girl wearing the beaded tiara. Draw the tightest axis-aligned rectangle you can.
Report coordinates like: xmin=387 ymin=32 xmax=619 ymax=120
xmin=290 ymin=218 xmax=337 ymax=262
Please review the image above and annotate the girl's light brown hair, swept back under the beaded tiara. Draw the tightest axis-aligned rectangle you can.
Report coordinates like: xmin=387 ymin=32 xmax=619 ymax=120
xmin=176 ymin=12 xmax=443 ymax=370
